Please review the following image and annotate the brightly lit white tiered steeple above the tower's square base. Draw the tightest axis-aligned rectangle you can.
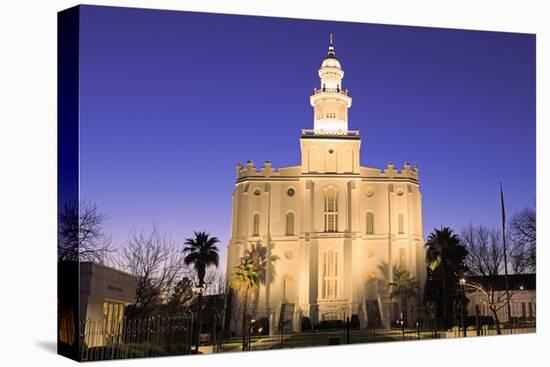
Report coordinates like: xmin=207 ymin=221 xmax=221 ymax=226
xmin=310 ymin=33 xmax=351 ymax=134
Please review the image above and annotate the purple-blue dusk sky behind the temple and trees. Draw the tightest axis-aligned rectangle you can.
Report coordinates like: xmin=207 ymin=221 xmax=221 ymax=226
xmin=76 ymin=6 xmax=536 ymax=270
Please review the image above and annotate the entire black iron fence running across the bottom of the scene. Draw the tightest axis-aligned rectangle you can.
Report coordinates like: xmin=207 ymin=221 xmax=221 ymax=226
xmin=74 ymin=312 xmax=536 ymax=361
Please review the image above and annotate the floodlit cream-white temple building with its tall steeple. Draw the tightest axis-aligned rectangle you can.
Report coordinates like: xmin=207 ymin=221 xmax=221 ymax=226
xmin=227 ymin=36 xmax=426 ymax=333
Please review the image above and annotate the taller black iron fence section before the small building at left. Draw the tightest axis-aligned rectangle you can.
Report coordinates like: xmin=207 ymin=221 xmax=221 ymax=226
xmin=80 ymin=312 xmax=193 ymax=361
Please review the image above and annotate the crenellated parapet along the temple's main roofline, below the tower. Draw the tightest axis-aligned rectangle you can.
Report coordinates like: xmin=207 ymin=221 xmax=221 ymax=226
xmin=237 ymin=161 xmax=418 ymax=182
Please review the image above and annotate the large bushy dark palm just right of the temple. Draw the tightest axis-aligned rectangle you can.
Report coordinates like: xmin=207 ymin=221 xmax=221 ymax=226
xmin=425 ymin=227 xmax=468 ymax=323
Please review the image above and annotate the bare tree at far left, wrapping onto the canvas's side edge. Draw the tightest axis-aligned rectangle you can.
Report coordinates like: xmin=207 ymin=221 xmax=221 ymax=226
xmin=57 ymin=201 xmax=115 ymax=263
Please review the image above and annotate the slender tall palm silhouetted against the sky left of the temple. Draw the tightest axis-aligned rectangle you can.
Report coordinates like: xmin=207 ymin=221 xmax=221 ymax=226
xmin=183 ymin=231 xmax=220 ymax=353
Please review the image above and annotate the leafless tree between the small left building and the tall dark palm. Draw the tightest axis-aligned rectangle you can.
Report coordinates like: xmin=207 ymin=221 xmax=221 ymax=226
xmin=118 ymin=227 xmax=186 ymax=317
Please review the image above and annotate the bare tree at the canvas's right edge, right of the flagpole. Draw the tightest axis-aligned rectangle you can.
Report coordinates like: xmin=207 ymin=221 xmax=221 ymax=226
xmin=509 ymin=208 xmax=537 ymax=272
